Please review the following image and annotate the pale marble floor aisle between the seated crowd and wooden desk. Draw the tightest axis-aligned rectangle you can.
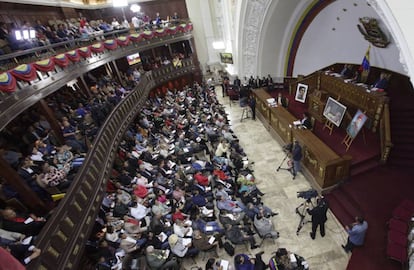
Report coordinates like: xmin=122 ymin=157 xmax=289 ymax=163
xmin=184 ymin=89 xmax=350 ymax=270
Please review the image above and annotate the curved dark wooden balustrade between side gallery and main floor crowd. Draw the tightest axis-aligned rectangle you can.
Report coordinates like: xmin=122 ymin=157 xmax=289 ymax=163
xmin=28 ymin=59 xmax=197 ymax=270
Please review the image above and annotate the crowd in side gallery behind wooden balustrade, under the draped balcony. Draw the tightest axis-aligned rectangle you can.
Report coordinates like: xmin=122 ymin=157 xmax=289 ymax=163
xmin=0 ymin=76 xmax=134 ymax=203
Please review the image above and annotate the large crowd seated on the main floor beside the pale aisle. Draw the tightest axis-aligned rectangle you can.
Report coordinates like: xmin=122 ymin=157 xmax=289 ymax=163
xmin=83 ymin=83 xmax=277 ymax=269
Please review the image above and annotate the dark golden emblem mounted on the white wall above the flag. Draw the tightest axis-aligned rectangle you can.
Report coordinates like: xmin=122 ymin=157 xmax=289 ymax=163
xmin=357 ymin=17 xmax=390 ymax=48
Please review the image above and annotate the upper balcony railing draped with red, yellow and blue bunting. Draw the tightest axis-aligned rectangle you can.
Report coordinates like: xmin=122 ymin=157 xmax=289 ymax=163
xmin=0 ymin=25 xmax=192 ymax=130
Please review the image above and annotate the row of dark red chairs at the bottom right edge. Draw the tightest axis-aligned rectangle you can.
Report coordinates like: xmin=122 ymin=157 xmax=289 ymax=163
xmin=386 ymin=200 xmax=414 ymax=268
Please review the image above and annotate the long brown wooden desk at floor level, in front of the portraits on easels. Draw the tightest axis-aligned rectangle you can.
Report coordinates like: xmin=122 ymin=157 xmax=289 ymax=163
xmin=253 ymin=89 xmax=351 ymax=189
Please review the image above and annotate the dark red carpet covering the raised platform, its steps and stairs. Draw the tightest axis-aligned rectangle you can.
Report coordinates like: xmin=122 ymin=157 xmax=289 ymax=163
xmin=273 ymin=88 xmax=414 ymax=270
